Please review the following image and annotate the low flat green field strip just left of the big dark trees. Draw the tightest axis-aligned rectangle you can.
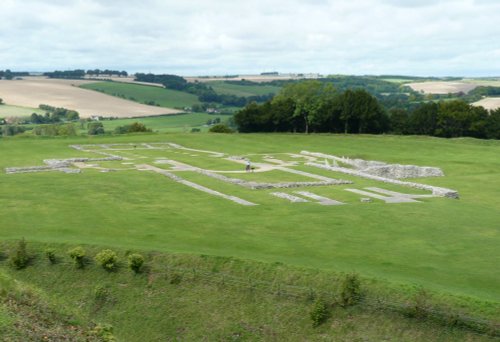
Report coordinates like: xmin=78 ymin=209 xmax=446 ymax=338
xmin=101 ymin=113 xmax=229 ymax=133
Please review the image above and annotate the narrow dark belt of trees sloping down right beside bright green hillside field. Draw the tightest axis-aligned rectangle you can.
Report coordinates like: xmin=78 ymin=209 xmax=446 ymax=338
xmin=135 ymin=73 xmax=274 ymax=107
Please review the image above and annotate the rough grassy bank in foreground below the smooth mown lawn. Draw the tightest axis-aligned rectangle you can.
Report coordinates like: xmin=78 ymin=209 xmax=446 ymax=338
xmin=0 ymin=244 xmax=499 ymax=341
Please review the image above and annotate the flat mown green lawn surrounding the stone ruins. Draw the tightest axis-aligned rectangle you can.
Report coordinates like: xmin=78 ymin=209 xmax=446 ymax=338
xmin=0 ymin=134 xmax=500 ymax=302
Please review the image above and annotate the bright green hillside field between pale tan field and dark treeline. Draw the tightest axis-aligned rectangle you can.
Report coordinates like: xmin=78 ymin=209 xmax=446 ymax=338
xmin=80 ymin=82 xmax=200 ymax=108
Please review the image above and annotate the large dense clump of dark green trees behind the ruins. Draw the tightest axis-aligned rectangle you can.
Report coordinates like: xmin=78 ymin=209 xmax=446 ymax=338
xmin=234 ymin=81 xmax=500 ymax=139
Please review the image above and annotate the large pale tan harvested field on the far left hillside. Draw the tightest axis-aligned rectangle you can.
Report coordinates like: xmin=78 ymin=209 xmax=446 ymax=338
xmin=0 ymin=77 xmax=179 ymax=117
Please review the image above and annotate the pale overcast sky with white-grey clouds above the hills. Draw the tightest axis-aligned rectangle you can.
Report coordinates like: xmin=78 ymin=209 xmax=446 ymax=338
xmin=0 ymin=0 xmax=500 ymax=76
